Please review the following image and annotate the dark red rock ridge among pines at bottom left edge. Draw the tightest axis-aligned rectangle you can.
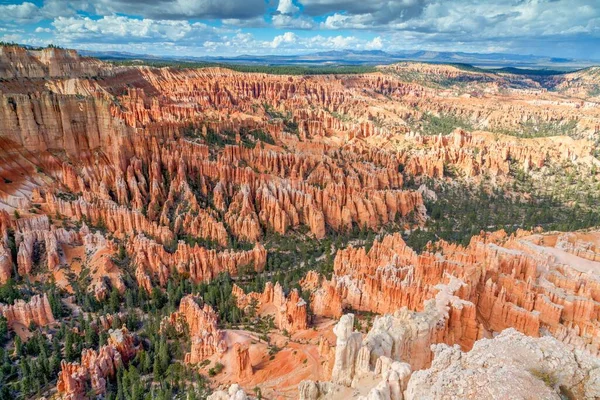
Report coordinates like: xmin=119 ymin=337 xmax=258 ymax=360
xmin=56 ymin=328 xmax=136 ymax=400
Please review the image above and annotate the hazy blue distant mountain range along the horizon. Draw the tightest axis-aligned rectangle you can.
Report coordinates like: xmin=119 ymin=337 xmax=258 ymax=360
xmin=79 ymin=50 xmax=600 ymax=70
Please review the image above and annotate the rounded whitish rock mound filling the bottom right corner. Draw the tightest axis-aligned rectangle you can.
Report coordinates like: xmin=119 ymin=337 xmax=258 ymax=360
xmin=405 ymin=328 xmax=600 ymax=400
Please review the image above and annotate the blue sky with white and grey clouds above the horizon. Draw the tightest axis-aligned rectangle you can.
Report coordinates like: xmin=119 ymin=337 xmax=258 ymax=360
xmin=0 ymin=0 xmax=600 ymax=60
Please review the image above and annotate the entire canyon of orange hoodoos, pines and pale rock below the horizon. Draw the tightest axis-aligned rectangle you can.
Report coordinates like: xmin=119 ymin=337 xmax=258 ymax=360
xmin=0 ymin=46 xmax=600 ymax=400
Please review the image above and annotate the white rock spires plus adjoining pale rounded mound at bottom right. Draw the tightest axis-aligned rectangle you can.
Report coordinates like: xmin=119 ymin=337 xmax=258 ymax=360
xmin=298 ymin=320 xmax=600 ymax=400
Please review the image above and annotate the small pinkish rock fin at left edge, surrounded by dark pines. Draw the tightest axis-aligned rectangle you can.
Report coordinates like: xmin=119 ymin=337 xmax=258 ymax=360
xmin=0 ymin=294 xmax=54 ymax=327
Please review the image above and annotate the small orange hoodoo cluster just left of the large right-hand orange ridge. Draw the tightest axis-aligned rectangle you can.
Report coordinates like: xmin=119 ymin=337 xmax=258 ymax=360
xmin=232 ymin=282 xmax=308 ymax=333
